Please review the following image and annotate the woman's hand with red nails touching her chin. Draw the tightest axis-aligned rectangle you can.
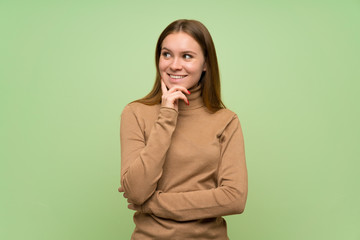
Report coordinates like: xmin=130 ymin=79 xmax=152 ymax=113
xmin=161 ymin=79 xmax=190 ymax=111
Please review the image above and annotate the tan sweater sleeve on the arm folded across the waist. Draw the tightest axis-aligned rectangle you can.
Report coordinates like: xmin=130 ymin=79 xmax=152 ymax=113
xmin=142 ymin=115 xmax=248 ymax=221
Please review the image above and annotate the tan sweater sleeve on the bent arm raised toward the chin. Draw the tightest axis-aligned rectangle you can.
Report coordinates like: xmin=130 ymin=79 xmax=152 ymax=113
xmin=120 ymin=105 xmax=178 ymax=205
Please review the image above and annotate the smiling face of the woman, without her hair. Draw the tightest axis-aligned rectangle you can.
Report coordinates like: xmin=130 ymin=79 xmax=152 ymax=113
xmin=159 ymin=32 xmax=206 ymax=89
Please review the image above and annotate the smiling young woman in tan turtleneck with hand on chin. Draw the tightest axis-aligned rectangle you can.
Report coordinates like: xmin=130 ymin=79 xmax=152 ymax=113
xmin=119 ymin=20 xmax=247 ymax=240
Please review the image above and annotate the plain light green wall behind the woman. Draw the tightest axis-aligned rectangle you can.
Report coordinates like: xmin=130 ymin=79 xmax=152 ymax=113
xmin=0 ymin=0 xmax=360 ymax=240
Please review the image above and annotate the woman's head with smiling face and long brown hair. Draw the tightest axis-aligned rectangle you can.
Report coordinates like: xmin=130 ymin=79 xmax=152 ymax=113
xmin=136 ymin=19 xmax=225 ymax=112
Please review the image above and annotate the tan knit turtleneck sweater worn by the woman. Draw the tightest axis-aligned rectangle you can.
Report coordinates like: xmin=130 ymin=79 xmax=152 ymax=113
xmin=120 ymin=83 xmax=247 ymax=240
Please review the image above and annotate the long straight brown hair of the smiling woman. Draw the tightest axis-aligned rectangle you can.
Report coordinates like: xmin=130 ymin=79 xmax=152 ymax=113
xmin=135 ymin=19 xmax=225 ymax=112
